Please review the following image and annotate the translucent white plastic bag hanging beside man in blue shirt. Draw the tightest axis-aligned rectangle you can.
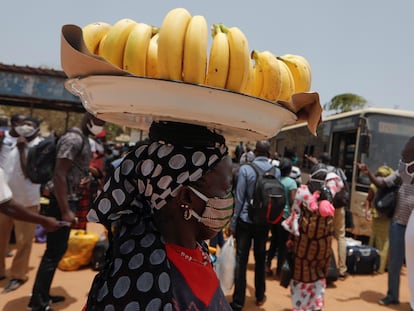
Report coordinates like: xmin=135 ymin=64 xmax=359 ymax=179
xmin=214 ymin=235 xmax=236 ymax=295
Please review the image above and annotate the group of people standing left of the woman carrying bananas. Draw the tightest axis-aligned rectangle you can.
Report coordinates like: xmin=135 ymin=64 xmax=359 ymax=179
xmin=0 ymin=113 xmax=131 ymax=310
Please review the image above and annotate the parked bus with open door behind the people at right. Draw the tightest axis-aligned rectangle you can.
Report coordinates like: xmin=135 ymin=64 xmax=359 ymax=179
xmin=270 ymin=108 xmax=414 ymax=237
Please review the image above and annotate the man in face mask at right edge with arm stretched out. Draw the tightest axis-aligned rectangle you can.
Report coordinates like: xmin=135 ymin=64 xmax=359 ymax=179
xmin=357 ymin=137 xmax=414 ymax=308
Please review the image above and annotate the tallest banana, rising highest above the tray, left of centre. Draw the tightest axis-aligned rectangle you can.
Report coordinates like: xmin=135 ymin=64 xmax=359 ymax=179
xmin=158 ymin=8 xmax=191 ymax=80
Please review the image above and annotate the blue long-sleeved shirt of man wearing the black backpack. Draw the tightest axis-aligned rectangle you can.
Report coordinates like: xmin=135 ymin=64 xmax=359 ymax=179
xmin=230 ymin=156 xmax=280 ymax=231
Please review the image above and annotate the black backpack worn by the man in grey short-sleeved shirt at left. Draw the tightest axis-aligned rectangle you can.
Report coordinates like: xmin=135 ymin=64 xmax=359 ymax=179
xmin=26 ymin=130 xmax=84 ymax=184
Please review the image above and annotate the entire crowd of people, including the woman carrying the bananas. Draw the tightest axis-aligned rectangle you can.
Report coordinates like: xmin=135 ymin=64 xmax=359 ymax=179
xmin=0 ymin=112 xmax=414 ymax=311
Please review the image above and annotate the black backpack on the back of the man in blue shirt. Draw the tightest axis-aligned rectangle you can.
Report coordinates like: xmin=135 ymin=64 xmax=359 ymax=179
xmin=247 ymin=163 xmax=286 ymax=224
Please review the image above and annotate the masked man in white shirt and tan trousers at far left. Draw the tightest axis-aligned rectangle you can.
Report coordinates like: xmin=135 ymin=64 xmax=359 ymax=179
xmin=0 ymin=115 xmax=41 ymax=293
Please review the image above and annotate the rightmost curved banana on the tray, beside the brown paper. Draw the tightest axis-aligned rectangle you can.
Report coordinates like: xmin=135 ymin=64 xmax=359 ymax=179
xmin=278 ymin=54 xmax=312 ymax=93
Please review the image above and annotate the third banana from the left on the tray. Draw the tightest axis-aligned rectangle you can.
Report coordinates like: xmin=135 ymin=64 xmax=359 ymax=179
xmin=123 ymin=23 xmax=152 ymax=76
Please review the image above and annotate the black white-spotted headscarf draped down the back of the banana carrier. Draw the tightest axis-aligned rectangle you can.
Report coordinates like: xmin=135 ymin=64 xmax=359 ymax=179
xmin=87 ymin=122 xmax=228 ymax=310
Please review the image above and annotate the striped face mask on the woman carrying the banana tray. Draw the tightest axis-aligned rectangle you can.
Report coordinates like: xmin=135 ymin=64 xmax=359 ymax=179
xmin=189 ymin=187 xmax=234 ymax=232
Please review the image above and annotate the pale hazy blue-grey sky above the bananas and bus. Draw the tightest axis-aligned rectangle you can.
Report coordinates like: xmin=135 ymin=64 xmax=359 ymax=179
xmin=0 ymin=0 xmax=414 ymax=110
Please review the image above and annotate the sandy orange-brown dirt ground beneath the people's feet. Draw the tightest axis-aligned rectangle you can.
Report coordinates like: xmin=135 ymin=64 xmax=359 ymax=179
xmin=0 ymin=224 xmax=410 ymax=311
